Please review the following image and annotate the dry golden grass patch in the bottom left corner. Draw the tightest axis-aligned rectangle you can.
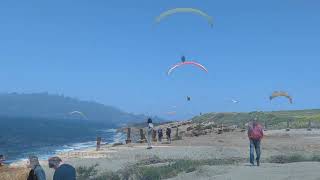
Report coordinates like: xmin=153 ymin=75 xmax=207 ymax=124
xmin=0 ymin=166 xmax=29 ymax=180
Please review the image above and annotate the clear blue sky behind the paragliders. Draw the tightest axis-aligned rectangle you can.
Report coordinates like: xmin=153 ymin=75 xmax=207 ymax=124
xmin=0 ymin=0 xmax=320 ymax=118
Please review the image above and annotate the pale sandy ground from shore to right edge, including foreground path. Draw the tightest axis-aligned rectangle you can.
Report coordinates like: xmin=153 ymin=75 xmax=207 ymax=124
xmin=0 ymin=124 xmax=320 ymax=180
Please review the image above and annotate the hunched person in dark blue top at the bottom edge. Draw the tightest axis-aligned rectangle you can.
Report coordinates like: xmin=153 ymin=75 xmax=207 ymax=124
xmin=48 ymin=157 xmax=76 ymax=180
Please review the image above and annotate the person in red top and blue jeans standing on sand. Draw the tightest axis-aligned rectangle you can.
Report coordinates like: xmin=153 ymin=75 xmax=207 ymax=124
xmin=248 ymin=118 xmax=263 ymax=166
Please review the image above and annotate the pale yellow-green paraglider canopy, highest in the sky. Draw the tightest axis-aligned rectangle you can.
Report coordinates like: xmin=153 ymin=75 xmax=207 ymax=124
xmin=156 ymin=8 xmax=213 ymax=27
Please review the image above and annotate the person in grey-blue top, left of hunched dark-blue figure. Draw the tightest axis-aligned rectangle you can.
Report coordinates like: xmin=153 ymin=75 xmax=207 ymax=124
xmin=27 ymin=156 xmax=46 ymax=180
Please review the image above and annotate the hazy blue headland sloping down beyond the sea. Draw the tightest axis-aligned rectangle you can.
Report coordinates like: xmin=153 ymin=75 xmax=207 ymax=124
xmin=0 ymin=93 xmax=161 ymax=126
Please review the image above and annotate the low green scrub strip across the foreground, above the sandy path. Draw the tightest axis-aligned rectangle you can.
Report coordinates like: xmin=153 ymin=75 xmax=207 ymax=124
xmin=77 ymin=156 xmax=246 ymax=180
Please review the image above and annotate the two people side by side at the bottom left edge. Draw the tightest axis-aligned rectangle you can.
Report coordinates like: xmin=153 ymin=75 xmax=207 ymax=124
xmin=27 ymin=156 xmax=76 ymax=180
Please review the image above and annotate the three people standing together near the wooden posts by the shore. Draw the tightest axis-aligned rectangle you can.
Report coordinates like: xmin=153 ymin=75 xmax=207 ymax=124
xmin=147 ymin=118 xmax=171 ymax=149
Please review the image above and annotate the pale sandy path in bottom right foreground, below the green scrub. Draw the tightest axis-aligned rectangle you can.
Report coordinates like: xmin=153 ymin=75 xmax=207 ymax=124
xmin=171 ymin=162 xmax=320 ymax=180
